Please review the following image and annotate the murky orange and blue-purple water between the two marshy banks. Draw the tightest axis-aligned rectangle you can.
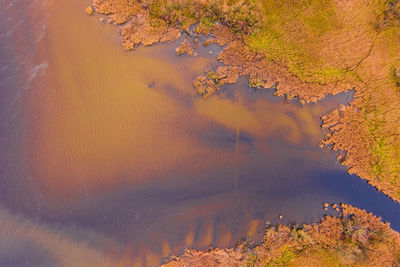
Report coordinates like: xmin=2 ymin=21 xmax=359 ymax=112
xmin=0 ymin=0 xmax=400 ymax=266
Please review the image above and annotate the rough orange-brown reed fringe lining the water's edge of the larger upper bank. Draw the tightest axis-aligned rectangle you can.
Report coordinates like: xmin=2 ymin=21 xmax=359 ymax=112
xmin=87 ymin=0 xmax=400 ymax=202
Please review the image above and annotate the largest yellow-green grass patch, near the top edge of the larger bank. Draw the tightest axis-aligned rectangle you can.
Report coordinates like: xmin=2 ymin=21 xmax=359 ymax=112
xmin=246 ymin=0 xmax=346 ymax=84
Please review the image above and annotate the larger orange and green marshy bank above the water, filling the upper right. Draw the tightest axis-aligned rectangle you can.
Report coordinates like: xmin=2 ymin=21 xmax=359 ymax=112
xmin=89 ymin=0 xmax=400 ymax=201
